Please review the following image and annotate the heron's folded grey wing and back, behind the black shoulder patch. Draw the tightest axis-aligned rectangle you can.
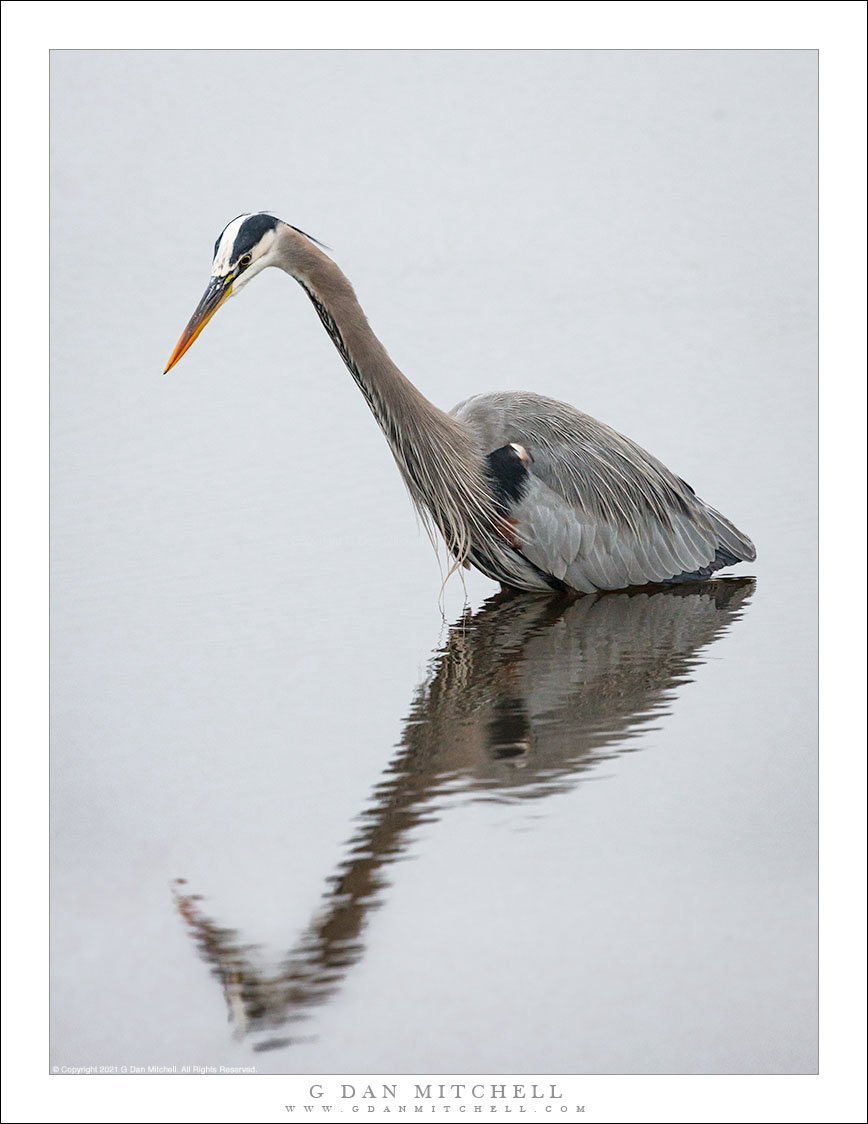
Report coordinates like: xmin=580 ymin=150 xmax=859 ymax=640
xmin=452 ymin=393 xmax=756 ymax=592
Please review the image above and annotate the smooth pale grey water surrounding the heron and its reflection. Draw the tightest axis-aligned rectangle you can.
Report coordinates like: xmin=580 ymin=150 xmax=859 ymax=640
xmin=52 ymin=51 xmax=816 ymax=1073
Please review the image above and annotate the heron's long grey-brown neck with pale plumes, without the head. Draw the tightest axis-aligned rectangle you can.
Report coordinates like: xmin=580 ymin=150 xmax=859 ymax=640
xmin=270 ymin=227 xmax=512 ymax=579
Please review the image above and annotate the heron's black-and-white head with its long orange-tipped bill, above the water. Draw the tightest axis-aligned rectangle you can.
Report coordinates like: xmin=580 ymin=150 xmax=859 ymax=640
xmin=166 ymin=211 xmax=281 ymax=371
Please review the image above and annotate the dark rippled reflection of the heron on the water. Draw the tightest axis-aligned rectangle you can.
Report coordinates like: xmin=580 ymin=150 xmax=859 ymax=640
xmin=174 ymin=578 xmax=754 ymax=1050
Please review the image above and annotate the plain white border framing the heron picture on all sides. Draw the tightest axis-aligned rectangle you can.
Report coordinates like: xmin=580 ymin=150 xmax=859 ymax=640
xmin=2 ymin=0 xmax=866 ymax=1122
